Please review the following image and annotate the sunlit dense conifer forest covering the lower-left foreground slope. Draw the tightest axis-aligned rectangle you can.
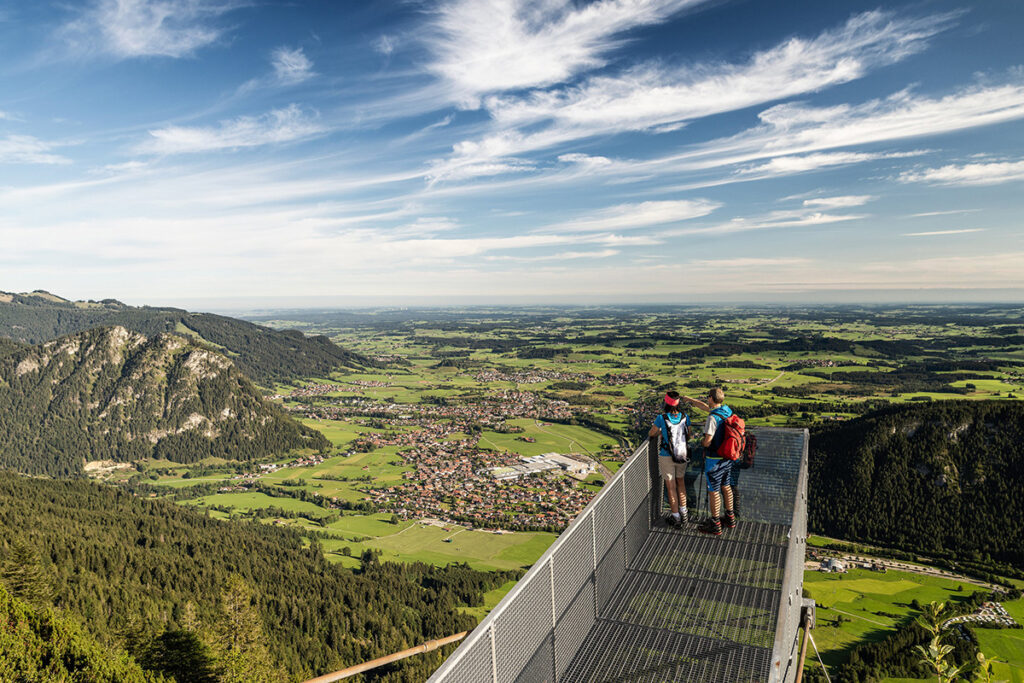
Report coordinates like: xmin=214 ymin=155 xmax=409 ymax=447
xmin=0 ymin=473 xmax=514 ymax=683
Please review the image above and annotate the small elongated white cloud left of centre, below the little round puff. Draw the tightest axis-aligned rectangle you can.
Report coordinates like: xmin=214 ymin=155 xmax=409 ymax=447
xmin=138 ymin=104 xmax=325 ymax=155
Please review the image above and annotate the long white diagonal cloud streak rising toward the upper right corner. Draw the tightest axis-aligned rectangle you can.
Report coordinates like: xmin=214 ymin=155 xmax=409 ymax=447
xmin=486 ymin=11 xmax=948 ymax=131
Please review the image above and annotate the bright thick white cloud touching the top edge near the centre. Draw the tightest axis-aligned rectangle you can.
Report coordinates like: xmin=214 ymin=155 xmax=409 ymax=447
xmin=427 ymin=0 xmax=707 ymax=108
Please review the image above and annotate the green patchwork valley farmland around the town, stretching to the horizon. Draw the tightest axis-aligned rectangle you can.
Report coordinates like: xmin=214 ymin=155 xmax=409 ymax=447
xmin=92 ymin=306 xmax=1024 ymax=630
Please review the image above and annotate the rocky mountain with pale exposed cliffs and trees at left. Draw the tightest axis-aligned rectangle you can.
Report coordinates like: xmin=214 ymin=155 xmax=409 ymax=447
xmin=0 ymin=327 xmax=328 ymax=476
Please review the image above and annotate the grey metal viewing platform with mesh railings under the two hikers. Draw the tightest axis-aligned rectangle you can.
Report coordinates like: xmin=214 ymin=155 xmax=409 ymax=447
xmin=430 ymin=428 xmax=808 ymax=683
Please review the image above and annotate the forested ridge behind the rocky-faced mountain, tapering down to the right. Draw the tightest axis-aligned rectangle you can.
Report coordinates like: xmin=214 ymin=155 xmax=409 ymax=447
xmin=0 ymin=291 xmax=374 ymax=386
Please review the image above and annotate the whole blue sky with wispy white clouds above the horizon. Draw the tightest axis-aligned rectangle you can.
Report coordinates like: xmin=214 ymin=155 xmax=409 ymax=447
xmin=0 ymin=0 xmax=1024 ymax=305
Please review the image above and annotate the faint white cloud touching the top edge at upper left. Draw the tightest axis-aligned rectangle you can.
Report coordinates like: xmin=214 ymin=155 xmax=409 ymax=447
xmin=60 ymin=0 xmax=238 ymax=58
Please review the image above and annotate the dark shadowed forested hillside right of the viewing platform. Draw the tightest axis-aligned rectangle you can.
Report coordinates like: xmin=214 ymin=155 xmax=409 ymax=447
xmin=808 ymin=401 xmax=1024 ymax=568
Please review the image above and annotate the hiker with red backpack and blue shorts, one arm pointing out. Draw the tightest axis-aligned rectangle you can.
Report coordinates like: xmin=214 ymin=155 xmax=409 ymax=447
xmin=683 ymin=387 xmax=739 ymax=536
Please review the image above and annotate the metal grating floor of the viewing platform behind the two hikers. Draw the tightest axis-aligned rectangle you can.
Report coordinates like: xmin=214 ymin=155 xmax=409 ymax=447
xmin=560 ymin=522 xmax=788 ymax=683
